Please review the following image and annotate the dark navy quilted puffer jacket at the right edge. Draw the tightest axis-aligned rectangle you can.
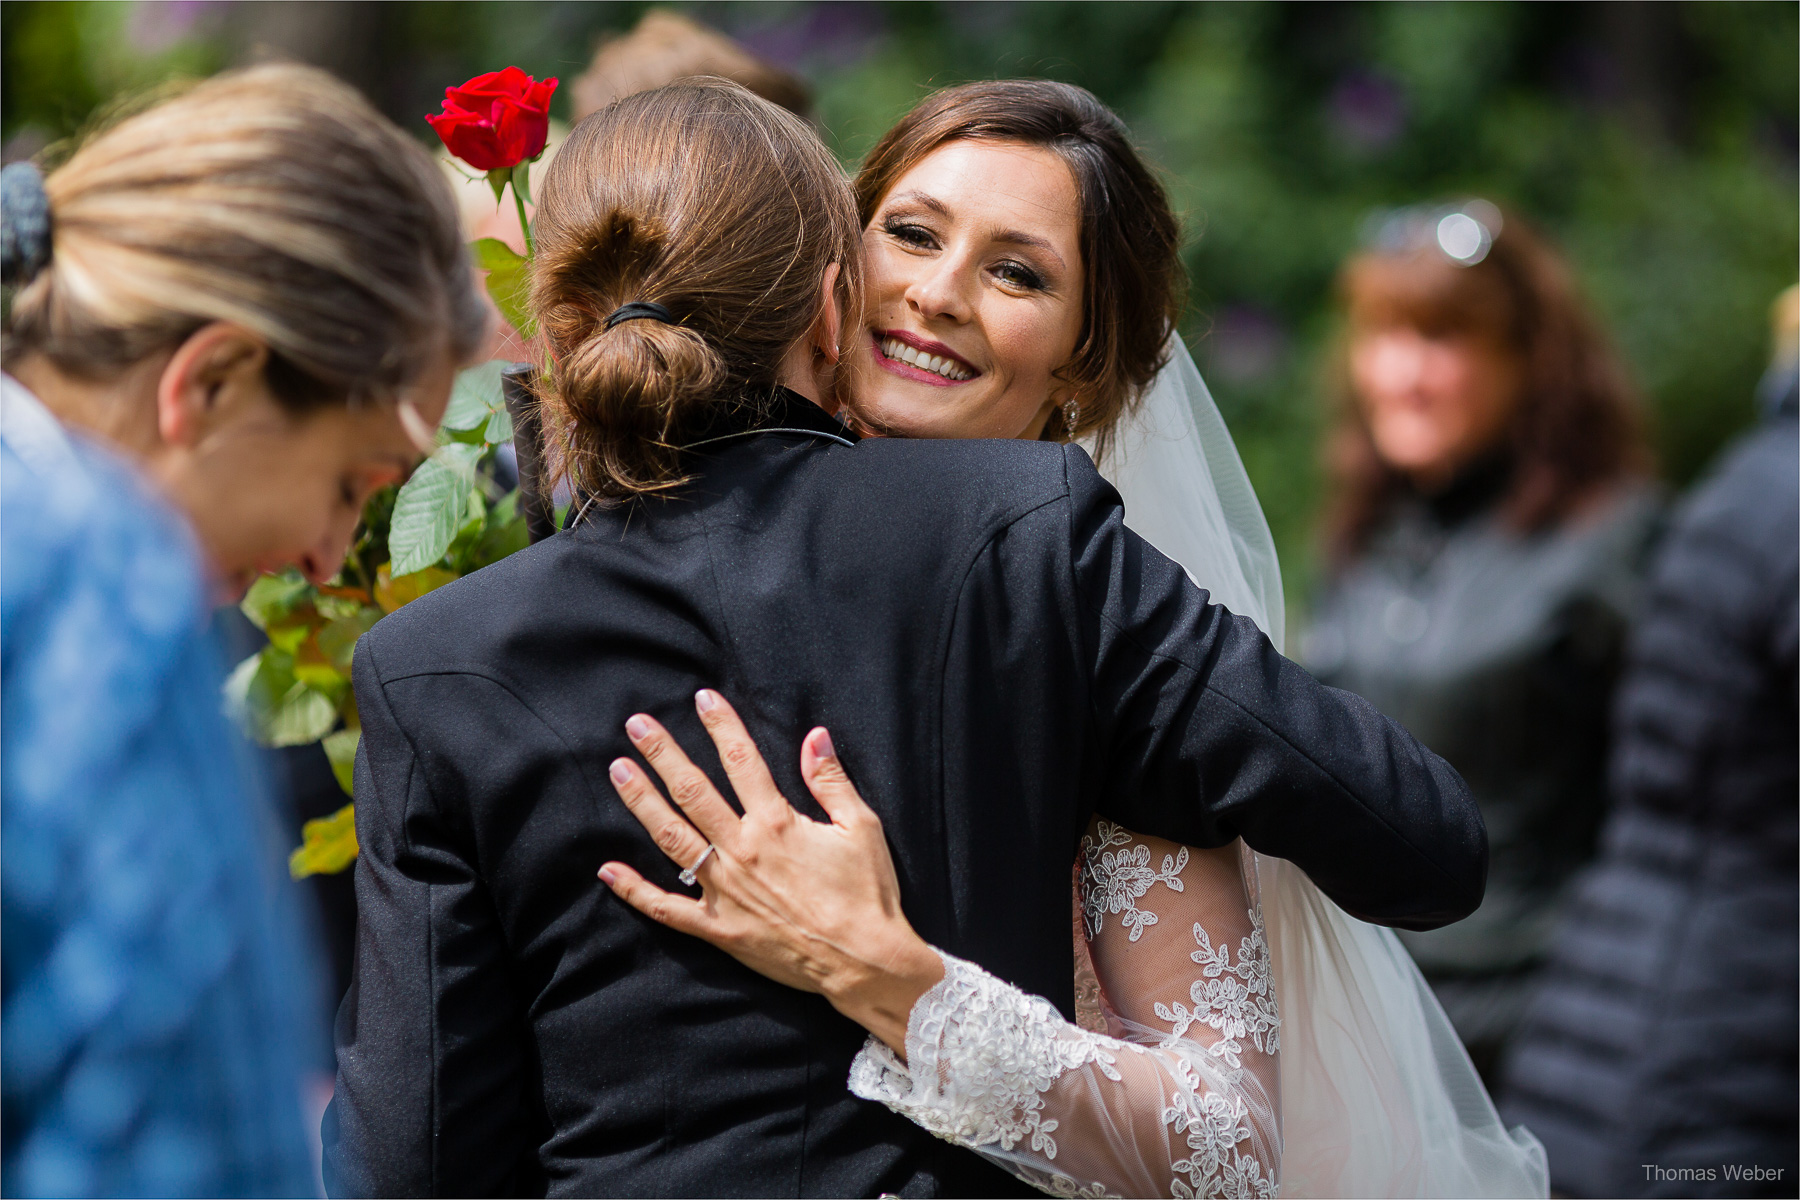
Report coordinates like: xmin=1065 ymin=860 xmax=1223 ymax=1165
xmin=1503 ymin=392 xmax=1800 ymax=1196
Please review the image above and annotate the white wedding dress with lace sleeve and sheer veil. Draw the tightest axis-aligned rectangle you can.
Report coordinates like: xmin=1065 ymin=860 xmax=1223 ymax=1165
xmin=850 ymin=336 xmax=1548 ymax=1196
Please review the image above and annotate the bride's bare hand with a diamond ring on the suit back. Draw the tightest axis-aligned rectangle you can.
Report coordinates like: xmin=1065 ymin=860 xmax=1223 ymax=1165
xmin=599 ymin=689 xmax=943 ymax=1056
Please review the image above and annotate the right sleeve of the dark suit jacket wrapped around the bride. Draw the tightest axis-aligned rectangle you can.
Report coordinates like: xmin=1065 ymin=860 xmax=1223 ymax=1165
xmin=1066 ymin=448 xmax=1487 ymax=928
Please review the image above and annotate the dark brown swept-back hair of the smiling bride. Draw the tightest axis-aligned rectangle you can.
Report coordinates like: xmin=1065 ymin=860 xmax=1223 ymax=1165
xmin=857 ymin=79 xmax=1186 ymax=450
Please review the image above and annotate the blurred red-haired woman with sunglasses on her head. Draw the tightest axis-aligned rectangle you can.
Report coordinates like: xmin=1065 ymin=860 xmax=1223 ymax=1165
xmin=1303 ymin=200 xmax=1658 ymax=1078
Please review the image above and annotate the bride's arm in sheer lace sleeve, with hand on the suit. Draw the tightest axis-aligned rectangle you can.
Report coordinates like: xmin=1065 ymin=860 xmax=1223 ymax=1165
xmin=601 ymin=698 xmax=1280 ymax=1196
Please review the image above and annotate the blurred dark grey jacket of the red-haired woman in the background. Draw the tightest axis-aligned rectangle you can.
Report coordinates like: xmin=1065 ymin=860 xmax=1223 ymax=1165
xmin=1303 ymin=461 xmax=1658 ymax=1067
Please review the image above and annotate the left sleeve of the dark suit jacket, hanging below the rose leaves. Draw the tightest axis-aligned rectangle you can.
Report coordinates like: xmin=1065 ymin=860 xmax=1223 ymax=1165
xmin=322 ymin=639 xmax=542 ymax=1196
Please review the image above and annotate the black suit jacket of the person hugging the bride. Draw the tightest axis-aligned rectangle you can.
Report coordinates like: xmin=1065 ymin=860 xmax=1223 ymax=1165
xmin=326 ymin=394 xmax=1487 ymax=1196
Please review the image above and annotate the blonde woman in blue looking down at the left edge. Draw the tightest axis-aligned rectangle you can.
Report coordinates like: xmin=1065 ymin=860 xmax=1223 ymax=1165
xmin=0 ymin=67 xmax=484 ymax=1196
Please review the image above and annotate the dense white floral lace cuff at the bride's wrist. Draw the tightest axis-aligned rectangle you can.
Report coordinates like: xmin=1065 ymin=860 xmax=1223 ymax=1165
xmin=850 ymin=952 xmax=1136 ymax=1159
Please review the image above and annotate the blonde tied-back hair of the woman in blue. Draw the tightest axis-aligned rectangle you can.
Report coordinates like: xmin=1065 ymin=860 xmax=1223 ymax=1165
xmin=5 ymin=65 xmax=486 ymax=410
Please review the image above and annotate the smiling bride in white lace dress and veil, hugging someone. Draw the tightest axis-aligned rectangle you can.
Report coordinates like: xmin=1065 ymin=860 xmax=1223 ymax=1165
xmin=601 ymin=81 xmax=1546 ymax=1196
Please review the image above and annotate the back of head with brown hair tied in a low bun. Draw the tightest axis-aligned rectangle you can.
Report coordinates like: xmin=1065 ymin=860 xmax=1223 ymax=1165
xmin=531 ymin=79 xmax=860 ymax=498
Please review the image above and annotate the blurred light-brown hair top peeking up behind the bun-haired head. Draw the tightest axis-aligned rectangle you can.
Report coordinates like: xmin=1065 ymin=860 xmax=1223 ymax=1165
xmin=571 ymin=9 xmax=812 ymax=121
